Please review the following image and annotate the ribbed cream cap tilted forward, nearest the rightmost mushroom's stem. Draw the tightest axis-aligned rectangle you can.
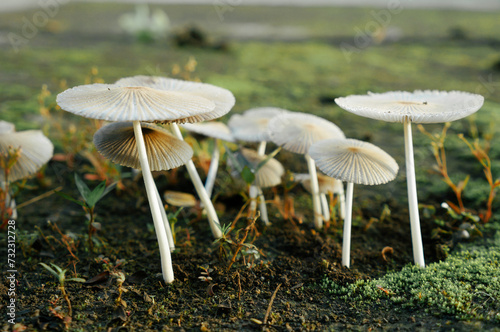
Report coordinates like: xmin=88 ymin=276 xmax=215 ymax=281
xmin=309 ymin=139 xmax=399 ymax=185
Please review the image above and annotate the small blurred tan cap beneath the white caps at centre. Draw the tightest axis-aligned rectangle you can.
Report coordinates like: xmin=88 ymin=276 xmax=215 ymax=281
xmin=240 ymin=148 xmax=285 ymax=188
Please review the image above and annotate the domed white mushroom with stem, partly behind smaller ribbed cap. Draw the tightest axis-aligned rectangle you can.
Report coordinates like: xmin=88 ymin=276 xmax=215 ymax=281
xmin=268 ymin=113 xmax=345 ymax=229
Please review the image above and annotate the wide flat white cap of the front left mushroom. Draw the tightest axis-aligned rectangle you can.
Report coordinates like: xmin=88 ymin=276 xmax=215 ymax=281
xmin=56 ymin=83 xmax=215 ymax=122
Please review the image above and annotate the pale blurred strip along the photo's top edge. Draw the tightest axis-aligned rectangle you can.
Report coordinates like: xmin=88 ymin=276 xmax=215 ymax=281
xmin=0 ymin=0 xmax=500 ymax=12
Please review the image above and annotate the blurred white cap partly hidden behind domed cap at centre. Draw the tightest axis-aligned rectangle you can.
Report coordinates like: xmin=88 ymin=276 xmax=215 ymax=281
xmin=228 ymin=107 xmax=290 ymax=142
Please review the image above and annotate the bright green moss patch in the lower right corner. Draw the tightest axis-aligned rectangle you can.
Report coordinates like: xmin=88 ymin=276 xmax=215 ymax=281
xmin=322 ymin=234 xmax=500 ymax=322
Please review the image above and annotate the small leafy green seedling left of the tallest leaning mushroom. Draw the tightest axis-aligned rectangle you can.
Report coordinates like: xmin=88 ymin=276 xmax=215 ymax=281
xmin=58 ymin=173 xmax=116 ymax=252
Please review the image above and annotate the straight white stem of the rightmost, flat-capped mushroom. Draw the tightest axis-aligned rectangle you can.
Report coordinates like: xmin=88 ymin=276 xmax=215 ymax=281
xmin=404 ymin=119 xmax=425 ymax=267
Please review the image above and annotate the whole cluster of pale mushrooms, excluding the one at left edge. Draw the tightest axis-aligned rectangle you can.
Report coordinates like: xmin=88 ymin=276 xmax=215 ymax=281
xmin=57 ymin=76 xmax=483 ymax=282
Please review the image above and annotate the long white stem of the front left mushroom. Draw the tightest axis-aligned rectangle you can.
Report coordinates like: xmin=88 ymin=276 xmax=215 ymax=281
xmin=133 ymin=121 xmax=174 ymax=283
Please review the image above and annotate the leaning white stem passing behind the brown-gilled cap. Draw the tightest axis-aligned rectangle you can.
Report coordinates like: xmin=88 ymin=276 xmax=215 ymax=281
xmin=171 ymin=123 xmax=222 ymax=239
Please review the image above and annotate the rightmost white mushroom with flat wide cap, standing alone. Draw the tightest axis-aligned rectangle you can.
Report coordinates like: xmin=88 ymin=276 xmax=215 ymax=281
xmin=335 ymin=90 xmax=484 ymax=267
